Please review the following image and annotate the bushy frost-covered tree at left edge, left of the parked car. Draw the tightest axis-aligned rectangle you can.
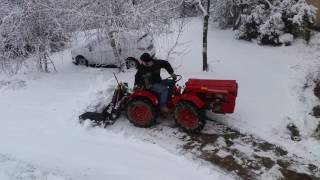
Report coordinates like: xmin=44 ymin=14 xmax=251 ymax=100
xmin=0 ymin=0 xmax=68 ymax=72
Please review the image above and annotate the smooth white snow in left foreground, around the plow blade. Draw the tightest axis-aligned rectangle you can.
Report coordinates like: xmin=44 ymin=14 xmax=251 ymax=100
xmin=0 ymin=57 xmax=231 ymax=180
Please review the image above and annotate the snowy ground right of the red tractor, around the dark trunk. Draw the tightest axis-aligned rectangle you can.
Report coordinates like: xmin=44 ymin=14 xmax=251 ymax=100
xmin=159 ymin=21 xmax=320 ymax=161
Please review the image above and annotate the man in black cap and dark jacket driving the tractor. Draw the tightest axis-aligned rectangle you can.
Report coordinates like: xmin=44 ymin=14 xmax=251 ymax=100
xmin=134 ymin=53 xmax=177 ymax=113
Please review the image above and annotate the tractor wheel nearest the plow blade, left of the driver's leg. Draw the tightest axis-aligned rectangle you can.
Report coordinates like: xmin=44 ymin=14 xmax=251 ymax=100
xmin=126 ymin=98 xmax=157 ymax=128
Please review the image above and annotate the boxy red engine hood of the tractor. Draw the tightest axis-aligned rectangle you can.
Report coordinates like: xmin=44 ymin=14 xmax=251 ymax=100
xmin=184 ymin=79 xmax=238 ymax=113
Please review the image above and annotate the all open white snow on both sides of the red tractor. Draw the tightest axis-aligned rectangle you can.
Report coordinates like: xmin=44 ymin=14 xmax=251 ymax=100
xmin=0 ymin=18 xmax=320 ymax=180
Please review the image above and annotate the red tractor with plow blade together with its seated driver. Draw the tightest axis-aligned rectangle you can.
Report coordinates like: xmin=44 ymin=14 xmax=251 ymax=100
xmin=79 ymin=53 xmax=238 ymax=133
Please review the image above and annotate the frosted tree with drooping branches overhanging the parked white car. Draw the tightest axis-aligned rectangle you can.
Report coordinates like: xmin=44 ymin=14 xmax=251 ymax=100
xmin=35 ymin=0 xmax=183 ymax=70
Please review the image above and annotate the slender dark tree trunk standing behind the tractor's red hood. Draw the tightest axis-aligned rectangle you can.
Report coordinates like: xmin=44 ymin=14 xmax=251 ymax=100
xmin=202 ymin=0 xmax=210 ymax=71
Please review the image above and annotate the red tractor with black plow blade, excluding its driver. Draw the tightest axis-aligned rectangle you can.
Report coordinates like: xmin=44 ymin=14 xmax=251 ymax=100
xmin=80 ymin=76 xmax=238 ymax=133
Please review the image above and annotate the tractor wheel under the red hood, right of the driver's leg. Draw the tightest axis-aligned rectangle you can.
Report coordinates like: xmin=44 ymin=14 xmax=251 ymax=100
xmin=173 ymin=102 xmax=206 ymax=133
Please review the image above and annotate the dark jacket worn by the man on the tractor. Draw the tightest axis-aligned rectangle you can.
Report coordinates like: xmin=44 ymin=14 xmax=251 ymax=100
xmin=134 ymin=60 xmax=173 ymax=88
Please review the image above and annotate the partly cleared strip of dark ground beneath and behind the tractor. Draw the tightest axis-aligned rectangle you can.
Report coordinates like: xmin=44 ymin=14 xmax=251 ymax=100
xmin=101 ymin=116 xmax=320 ymax=180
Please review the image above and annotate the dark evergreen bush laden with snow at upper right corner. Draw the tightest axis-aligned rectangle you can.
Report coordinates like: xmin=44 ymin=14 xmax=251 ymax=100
xmin=237 ymin=0 xmax=316 ymax=45
